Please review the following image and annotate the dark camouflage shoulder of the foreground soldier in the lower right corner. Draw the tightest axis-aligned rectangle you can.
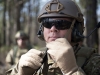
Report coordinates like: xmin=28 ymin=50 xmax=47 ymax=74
xmin=84 ymin=47 xmax=100 ymax=75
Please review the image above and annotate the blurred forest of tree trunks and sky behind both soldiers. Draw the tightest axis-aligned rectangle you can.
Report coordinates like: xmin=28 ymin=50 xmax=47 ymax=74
xmin=0 ymin=0 xmax=100 ymax=74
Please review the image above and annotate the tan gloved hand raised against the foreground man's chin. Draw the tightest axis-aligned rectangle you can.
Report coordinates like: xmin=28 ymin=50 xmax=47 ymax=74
xmin=46 ymin=38 xmax=78 ymax=75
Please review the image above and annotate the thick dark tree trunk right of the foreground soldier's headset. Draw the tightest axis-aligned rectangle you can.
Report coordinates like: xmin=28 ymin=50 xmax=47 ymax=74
xmin=86 ymin=0 xmax=98 ymax=47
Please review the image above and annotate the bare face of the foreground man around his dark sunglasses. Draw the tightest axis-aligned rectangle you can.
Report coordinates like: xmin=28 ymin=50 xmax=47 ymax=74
xmin=43 ymin=18 xmax=72 ymax=42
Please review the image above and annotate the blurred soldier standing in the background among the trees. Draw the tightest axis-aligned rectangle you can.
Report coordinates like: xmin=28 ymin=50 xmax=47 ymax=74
xmin=6 ymin=31 xmax=32 ymax=66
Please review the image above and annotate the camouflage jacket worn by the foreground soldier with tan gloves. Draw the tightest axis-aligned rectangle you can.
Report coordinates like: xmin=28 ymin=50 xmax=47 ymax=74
xmin=7 ymin=46 xmax=100 ymax=75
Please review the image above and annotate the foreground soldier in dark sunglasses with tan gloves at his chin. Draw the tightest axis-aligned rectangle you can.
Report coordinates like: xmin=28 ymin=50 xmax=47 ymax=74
xmin=7 ymin=0 xmax=100 ymax=75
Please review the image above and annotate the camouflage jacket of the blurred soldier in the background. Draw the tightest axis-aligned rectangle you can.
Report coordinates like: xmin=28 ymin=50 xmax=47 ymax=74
xmin=6 ymin=45 xmax=32 ymax=65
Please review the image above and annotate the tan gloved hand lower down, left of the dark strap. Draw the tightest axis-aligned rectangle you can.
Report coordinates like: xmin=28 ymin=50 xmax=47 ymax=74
xmin=18 ymin=49 xmax=44 ymax=75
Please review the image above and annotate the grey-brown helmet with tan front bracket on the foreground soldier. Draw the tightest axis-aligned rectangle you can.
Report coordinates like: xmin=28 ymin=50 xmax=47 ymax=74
xmin=38 ymin=0 xmax=84 ymax=42
